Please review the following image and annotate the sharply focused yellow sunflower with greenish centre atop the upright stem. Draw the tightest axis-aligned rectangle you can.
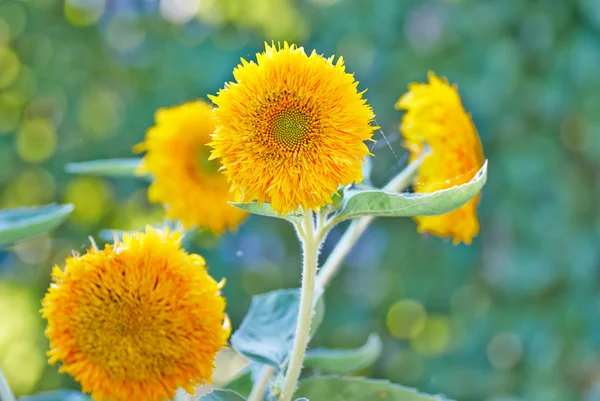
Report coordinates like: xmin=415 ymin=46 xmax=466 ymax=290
xmin=209 ymin=43 xmax=375 ymax=214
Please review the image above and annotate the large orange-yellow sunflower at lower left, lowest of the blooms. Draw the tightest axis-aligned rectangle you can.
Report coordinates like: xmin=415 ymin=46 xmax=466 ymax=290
xmin=42 ymin=227 xmax=230 ymax=401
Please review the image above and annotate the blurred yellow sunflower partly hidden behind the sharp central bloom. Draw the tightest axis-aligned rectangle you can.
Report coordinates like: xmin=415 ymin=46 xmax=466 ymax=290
xmin=134 ymin=101 xmax=247 ymax=234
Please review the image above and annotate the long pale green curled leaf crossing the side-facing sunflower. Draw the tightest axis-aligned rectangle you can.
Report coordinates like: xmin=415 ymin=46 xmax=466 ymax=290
xmin=335 ymin=161 xmax=487 ymax=222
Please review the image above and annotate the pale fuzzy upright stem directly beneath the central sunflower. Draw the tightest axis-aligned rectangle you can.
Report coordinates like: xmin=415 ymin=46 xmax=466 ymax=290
xmin=279 ymin=211 xmax=319 ymax=401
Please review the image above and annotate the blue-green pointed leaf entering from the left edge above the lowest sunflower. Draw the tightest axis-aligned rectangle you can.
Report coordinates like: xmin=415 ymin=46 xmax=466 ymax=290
xmin=0 ymin=203 xmax=73 ymax=245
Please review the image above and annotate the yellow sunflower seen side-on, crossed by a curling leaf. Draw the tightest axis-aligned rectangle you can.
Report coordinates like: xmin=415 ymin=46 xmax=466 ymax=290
xmin=396 ymin=73 xmax=484 ymax=244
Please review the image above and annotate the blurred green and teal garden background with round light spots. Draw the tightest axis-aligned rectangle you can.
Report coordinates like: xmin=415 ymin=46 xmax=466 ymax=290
xmin=0 ymin=0 xmax=600 ymax=401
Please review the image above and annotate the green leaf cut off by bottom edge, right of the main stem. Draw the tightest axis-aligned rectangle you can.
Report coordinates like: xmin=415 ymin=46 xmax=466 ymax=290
xmin=295 ymin=376 xmax=449 ymax=401
